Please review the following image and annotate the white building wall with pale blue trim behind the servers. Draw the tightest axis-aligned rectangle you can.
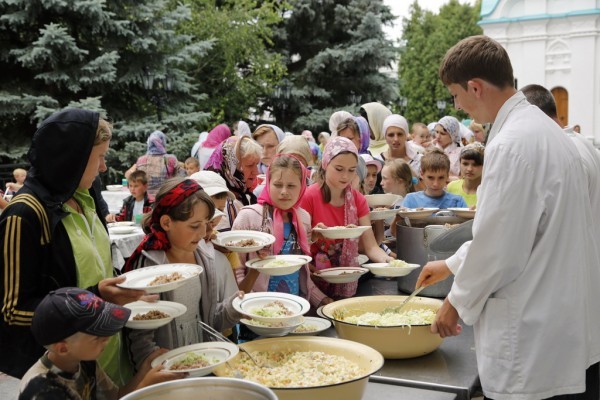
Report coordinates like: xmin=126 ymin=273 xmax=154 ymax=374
xmin=480 ymin=0 xmax=600 ymax=146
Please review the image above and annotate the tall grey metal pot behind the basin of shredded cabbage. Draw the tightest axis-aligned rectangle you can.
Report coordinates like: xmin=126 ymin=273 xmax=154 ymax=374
xmin=396 ymin=223 xmax=454 ymax=298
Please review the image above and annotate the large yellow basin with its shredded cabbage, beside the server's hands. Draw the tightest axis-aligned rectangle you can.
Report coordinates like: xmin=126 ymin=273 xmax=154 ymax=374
xmin=321 ymin=296 xmax=443 ymax=359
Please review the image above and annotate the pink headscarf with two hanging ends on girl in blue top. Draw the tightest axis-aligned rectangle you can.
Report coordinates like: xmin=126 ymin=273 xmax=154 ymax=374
xmin=258 ymin=154 xmax=310 ymax=254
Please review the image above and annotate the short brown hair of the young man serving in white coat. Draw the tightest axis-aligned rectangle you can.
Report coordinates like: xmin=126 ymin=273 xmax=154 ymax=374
xmin=439 ymin=35 xmax=515 ymax=90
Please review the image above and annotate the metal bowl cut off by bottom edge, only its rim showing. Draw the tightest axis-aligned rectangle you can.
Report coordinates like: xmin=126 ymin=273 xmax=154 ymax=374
xmin=122 ymin=378 xmax=277 ymax=400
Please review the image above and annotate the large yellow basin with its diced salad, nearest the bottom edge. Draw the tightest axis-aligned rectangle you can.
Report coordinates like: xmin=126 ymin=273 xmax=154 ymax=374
xmin=213 ymin=336 xmax=384 ymax=400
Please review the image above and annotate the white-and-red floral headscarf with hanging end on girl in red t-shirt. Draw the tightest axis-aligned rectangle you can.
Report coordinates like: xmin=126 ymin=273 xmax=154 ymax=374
xmin=321 ymin=136 xmax=358 ymax=272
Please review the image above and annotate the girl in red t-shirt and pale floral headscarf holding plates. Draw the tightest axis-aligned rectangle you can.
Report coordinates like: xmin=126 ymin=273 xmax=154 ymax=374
xmin=300 ymin=136 xmax=393 ymax=299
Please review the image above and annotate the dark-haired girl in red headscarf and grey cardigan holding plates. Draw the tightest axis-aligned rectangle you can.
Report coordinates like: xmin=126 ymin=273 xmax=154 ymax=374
xmin=124 ymin=178 xmax=243 ymax=366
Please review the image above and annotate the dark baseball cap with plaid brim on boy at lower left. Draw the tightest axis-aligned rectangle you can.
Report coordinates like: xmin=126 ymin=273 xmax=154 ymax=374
xmin=31 ymin=287 xmax=131 ymax=346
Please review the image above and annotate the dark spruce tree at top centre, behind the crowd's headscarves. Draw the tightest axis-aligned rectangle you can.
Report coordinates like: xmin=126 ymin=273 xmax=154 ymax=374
xmin=263 ymin=0 xmax=397 ymax=131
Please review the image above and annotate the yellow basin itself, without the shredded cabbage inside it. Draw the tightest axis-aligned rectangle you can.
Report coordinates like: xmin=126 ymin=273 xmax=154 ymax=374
xmin=321 ymin=296 xmax=443 ymax=359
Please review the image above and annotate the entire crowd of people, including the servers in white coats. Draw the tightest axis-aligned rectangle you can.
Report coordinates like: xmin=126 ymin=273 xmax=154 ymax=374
xmin=0 ymin=36 xmax=600 ymax=399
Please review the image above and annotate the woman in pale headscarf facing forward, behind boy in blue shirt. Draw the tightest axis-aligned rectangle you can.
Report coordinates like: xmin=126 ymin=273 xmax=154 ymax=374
xmin=378 ymin=114 xmax=423 ymax=177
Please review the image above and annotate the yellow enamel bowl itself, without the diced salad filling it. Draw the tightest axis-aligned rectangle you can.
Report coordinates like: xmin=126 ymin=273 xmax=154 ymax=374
xmin=213 ymin=336 xmax=384 ymax=400
